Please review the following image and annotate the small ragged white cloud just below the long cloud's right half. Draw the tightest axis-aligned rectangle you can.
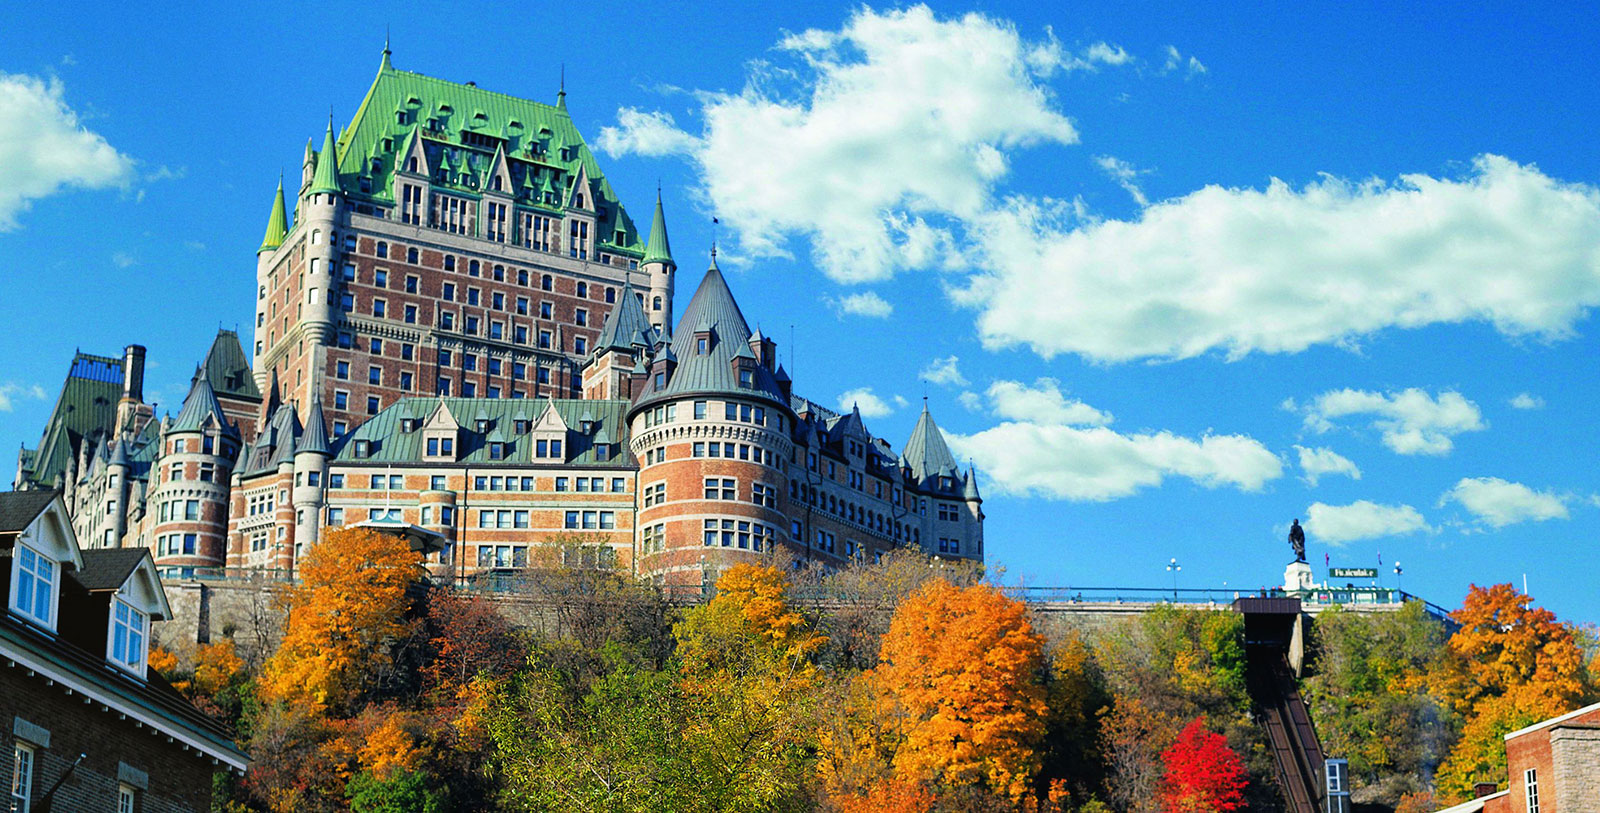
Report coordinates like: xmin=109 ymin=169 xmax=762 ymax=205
xmin=1283 ymin=387 xmax=1488 ymax=455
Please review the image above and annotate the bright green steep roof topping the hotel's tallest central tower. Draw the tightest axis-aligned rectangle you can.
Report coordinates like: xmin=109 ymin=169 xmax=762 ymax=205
xmin=328 ymin=59 xmax=645 ymax=258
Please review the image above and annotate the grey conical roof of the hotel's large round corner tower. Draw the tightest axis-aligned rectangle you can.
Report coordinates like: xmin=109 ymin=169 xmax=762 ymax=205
xmin=640 ymin=261 xmax=787 ymax=405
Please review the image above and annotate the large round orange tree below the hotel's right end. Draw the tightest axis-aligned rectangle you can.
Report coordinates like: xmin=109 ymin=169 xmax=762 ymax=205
xmin=869 ymin=579 xmax=1045 ymax=802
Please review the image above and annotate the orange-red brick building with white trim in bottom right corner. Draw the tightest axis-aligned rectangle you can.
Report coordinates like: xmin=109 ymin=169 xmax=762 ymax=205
xmin=1438 ymin=703 xmax=1600 ymax=813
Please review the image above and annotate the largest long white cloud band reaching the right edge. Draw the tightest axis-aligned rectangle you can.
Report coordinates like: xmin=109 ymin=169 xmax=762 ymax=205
xmin=957 ymin=155 xmax=1600 ymax=362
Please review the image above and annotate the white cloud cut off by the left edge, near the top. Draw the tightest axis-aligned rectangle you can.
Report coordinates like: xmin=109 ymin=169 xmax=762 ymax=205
xmin=0 ymin=72 xmax=133 ymax=232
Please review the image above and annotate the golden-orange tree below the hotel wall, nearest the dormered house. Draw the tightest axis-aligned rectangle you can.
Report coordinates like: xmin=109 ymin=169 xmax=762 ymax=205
xmin=261 ymin=528 xmax=422 ymax=711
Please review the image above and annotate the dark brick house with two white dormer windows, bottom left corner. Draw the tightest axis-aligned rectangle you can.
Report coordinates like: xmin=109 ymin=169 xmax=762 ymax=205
xmin=0 ymin=491 xmax=248 ymax=813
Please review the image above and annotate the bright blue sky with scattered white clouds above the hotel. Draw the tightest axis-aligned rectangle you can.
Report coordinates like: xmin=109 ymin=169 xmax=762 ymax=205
xmin=0 ymin=3 xmax=1600 ymax=621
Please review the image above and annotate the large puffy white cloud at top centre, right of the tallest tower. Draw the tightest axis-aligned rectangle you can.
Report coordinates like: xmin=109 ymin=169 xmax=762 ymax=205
xmin=605 ymin=5 xmax=1081 ymax=282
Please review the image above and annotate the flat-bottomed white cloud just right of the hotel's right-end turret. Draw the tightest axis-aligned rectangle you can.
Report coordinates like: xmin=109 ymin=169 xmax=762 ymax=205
xmin=949 ymin=378 xmax=1283 ymax=503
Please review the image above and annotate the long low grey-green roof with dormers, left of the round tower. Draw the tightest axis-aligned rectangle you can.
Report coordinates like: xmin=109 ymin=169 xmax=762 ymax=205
xmin=334 ymin=397 xmax=634 ymax=469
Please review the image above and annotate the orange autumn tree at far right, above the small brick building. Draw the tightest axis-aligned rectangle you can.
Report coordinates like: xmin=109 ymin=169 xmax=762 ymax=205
xmin=1427 ymin=584 xmax=1594 ymax=800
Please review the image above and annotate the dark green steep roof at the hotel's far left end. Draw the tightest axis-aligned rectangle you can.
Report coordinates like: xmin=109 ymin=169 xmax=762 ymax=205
xmin=16 ymin=352 xmax=122 ymax=487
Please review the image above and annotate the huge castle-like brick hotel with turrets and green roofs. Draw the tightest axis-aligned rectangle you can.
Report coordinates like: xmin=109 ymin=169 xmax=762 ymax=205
xmin=16 ymin=50 xmax=984 ymax=584
